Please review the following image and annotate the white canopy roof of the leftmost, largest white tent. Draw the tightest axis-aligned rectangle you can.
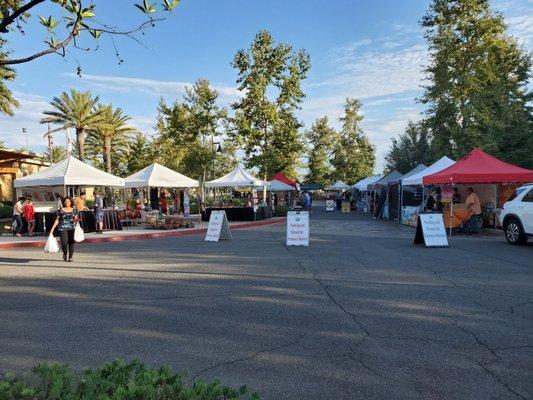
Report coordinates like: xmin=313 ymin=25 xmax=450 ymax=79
xmin=14 ymin=156 xmax=124 ymax=188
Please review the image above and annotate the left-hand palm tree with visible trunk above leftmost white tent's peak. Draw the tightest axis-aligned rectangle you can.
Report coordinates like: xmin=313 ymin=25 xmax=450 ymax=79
xmin=41 ymin=89 xmax=102 ymax=161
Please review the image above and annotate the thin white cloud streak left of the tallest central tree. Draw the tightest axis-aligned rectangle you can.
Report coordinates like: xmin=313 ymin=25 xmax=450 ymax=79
xmin=65 ymin=74 xmax=239 ymax=98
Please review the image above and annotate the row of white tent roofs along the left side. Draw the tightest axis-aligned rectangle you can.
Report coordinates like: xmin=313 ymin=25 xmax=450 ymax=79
xmin=14 ymin=156 xmax=295 ymax=190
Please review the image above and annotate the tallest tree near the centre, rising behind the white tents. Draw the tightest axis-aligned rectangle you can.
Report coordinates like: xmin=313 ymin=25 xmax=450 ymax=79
xmin=232 ymin=31 xmax=311 ymax=178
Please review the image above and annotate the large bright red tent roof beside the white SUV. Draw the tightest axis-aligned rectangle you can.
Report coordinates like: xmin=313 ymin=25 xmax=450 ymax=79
xmin=424 ymin=148 xmax=533 ymax=185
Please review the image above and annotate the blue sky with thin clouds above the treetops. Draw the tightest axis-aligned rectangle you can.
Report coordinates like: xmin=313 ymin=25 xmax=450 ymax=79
xmin=0 ymin=0 xmax=533 ymax=172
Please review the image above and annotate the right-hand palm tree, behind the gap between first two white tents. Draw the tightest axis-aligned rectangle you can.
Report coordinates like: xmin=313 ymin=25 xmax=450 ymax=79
xmin=87 ymin=105 xmax=136 ymax=173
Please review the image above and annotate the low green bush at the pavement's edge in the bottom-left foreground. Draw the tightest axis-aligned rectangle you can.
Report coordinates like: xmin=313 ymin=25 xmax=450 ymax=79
xmin=0 ymin=360 xmax=259 ymax=400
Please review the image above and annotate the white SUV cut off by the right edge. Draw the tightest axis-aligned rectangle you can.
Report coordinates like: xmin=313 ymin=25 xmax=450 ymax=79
xmin=500 ymin=183 xmax=533 ymax=244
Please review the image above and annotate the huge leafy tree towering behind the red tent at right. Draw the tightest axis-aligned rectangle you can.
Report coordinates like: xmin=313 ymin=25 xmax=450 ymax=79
xmin=421 ymin=0 xmax=533 ymax=167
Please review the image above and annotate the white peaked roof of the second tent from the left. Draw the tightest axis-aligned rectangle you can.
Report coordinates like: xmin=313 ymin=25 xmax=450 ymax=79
xmin=126 ymin=163 xmax=199 ymax=188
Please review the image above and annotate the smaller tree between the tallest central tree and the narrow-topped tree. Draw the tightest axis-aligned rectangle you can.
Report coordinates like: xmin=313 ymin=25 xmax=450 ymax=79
xmin=305 ymin=117 xmax=337 ymax=186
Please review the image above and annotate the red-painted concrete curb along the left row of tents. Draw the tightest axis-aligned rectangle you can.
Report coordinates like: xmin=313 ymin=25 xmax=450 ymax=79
xmin=0 ymin=217 xmax=286 ymax=249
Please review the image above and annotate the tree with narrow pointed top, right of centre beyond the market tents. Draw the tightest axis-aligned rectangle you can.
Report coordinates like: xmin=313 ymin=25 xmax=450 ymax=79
xmin=331 ymin=98 xmax=376 ymax=184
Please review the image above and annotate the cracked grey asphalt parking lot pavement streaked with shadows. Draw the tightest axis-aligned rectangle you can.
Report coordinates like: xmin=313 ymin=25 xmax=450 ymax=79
xmin=0 ymin=208 xmax=533 ymax=400
